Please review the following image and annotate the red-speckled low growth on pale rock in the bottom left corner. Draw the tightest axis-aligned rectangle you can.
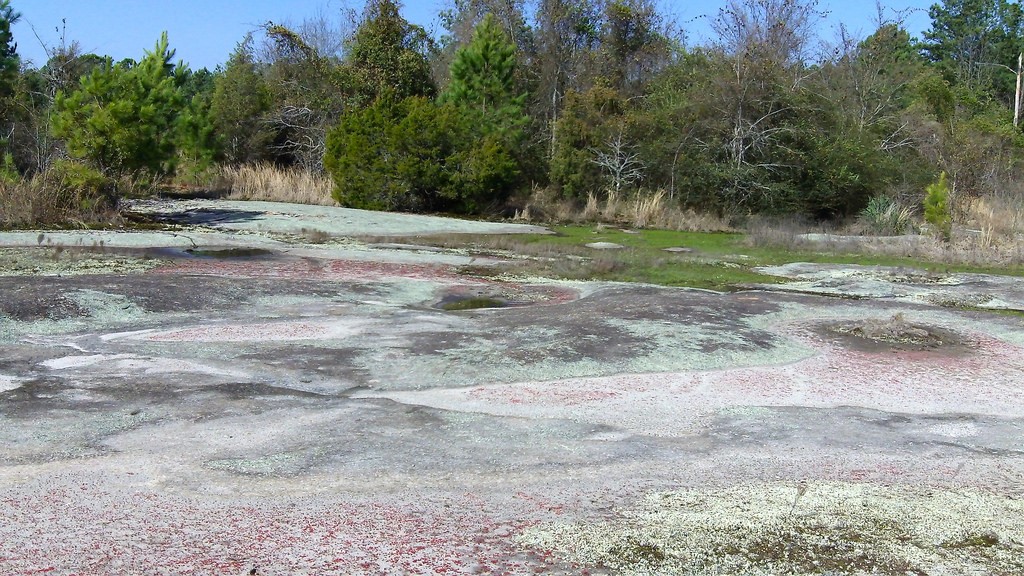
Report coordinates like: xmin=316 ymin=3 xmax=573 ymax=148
xmin=0 ymin=483 xmax=565 ymax=576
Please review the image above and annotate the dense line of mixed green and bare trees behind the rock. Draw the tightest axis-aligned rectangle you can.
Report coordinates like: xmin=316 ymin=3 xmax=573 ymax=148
xmin=0 ymin=0 xmax=1024 ymax=218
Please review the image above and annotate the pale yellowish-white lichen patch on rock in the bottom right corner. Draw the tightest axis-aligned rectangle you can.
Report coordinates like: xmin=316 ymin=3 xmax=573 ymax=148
xmin=519 ymin=482 xmax=1024 ymax=576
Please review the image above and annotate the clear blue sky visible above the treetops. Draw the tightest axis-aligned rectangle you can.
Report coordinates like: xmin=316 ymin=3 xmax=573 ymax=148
xmin=11 ymin=0 xmax=934 ymax=70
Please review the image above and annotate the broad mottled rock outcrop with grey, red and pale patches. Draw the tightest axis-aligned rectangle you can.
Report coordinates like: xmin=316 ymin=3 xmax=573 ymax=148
xmin=0 ymin=199 xmax=1024 ymax=575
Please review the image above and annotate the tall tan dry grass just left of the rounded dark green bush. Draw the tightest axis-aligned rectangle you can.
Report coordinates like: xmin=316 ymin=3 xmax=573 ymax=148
xmin=220 ymin=164 xmax=338 ymax=206
